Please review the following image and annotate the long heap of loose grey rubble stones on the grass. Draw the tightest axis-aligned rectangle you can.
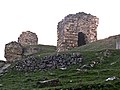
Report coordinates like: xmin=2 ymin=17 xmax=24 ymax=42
xmin=8 ymin=53 xmax=83 ymax=71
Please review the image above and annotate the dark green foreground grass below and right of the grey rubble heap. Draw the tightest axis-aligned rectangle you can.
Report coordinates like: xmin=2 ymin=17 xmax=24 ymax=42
xmin=0 ymin=49 xmax=120 ymax=90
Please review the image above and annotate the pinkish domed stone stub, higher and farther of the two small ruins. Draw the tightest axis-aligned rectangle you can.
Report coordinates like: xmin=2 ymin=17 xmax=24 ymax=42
xmin=18 ymin=31 xmax=38 ymax=46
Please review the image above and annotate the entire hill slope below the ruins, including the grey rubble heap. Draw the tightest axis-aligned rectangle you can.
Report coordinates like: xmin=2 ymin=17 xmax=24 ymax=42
xmin=0 ymin=35 xmax=120 ymax=90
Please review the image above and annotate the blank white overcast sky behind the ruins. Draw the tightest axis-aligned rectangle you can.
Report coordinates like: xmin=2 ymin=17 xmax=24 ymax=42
xmin=0 ymin=0 xmax=120 ymax=60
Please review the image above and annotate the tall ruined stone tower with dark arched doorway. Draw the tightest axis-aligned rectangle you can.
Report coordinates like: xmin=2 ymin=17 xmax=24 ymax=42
xmin=57 ymin=12 xmax=99 ymax=52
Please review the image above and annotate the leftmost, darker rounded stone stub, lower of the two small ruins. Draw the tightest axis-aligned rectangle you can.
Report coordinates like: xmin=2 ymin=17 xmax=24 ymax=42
xmin=4 ymin=41 xmax=23 ymax=62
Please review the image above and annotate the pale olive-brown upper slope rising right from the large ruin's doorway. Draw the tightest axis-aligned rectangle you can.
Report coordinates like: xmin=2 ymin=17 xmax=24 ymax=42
xmin=72 ymin=35 xmax=120 ymax=51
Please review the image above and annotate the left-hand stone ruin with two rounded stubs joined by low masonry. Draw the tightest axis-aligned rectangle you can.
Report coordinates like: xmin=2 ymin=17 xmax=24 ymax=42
xmin=4 ymin=31 xmax=40 ymax=62
